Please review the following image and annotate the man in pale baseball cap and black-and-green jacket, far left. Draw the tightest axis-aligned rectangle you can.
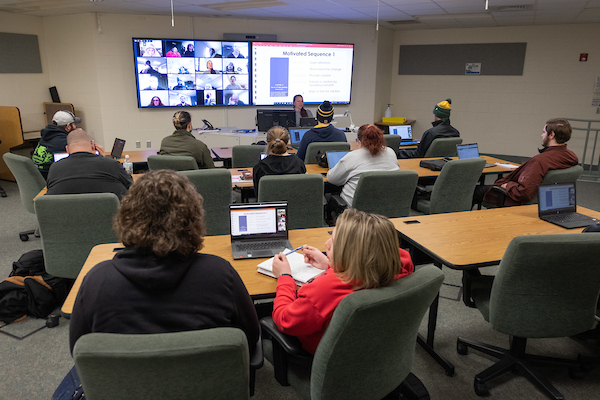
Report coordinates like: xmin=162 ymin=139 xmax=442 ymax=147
xmin=31 ymin=111 xmax=81 ymax=179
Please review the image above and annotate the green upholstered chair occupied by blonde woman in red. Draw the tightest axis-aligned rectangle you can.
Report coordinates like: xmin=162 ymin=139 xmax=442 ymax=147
xmin=261 ymin=265 xmax=444 ymax=400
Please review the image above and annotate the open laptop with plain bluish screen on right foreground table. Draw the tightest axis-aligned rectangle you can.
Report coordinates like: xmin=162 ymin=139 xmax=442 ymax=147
xmin=538 ymin=182 xmax=598 ymax=229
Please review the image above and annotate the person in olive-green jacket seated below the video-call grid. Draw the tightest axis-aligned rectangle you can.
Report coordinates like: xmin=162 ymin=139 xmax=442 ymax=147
xmin=158 ymin=111 xmax=215 ymax=169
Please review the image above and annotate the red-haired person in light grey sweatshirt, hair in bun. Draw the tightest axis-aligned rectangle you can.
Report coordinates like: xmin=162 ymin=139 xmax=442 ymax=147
xmin=327 ymin=125 xmax=400 ymax=207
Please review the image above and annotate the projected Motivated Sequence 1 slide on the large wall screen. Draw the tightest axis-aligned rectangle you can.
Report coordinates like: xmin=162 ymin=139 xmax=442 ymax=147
xmin=252 ymin=42 xmax=354 ymax=106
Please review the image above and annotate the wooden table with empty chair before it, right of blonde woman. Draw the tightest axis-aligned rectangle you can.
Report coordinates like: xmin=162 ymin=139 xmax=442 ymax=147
xmin=392 ymin=204 xmax=600 ymax=376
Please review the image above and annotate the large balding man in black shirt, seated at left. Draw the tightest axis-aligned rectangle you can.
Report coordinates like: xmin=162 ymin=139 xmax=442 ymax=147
xmin=47 ymin=128 xmax=133 ymax=198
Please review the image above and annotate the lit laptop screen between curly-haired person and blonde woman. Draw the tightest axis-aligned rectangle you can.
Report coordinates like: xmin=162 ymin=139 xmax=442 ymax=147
xmin=229 ymin=203 xmax=287 ymax=240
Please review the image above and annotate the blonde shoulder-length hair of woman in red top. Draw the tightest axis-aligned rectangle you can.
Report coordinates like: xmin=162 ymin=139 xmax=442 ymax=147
xmin=331 ymin=208 xmax=402 ymax=290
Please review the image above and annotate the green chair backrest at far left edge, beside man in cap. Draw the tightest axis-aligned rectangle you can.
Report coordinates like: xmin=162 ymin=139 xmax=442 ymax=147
xmin=2 ymin=153 xmax=46 ymax=214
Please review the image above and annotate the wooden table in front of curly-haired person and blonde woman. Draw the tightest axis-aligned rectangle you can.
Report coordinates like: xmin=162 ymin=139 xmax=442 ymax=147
xmin=61 ymin=227 xmax=332 ymax=315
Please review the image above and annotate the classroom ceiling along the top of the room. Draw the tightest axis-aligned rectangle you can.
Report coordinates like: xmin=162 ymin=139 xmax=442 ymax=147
xmin=0 ymin=0 xmax=600 ymax=30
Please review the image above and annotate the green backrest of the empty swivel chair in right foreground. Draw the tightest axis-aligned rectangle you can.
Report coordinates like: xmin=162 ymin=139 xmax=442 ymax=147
xmin=488 ymin=233 xmax=600 ymax=338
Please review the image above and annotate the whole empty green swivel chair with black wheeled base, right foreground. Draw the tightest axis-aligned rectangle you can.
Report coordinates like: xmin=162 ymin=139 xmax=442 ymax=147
xmin=457 ymin=233 xmax=600 ymax=399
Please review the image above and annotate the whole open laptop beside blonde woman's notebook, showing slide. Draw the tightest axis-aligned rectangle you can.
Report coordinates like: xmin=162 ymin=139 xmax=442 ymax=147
xmin=229 ymin=202 xmax=293 ymax=260
